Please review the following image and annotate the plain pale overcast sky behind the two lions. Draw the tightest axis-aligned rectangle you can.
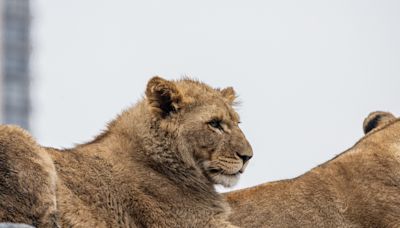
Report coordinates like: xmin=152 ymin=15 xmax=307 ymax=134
xmin=32 ymin=0 xmax=400 ymax=191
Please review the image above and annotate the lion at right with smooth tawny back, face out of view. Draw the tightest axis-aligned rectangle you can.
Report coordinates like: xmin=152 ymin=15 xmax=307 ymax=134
xmin=225 ymin=112 xmax=400 ymax=227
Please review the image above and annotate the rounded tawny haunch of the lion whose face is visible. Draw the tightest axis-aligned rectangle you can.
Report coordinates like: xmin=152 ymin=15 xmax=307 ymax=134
xmin=0 ymin=125 xmax=57 ymax=227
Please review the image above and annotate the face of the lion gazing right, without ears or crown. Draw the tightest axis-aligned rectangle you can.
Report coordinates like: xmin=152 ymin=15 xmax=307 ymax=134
xmin=179 ymin=103 xmax=253 ymax=186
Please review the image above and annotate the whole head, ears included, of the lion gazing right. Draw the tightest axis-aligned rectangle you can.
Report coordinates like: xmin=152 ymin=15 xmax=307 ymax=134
xmin=146 ymin=77 xmax=253 ymax=186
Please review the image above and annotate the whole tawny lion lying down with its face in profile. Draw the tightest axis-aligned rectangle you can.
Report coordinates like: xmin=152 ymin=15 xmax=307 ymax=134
xmin=0 ymin=77 xmax=253 ymax=227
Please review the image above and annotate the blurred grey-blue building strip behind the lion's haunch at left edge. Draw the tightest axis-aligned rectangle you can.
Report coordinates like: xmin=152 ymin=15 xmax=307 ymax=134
xmin=0 ymin=0 xmax=31 ymax=129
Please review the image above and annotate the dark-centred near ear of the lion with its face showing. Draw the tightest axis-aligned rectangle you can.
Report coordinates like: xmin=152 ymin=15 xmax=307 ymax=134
xmin=146 ymin=76 xmax=182 ymax=117
